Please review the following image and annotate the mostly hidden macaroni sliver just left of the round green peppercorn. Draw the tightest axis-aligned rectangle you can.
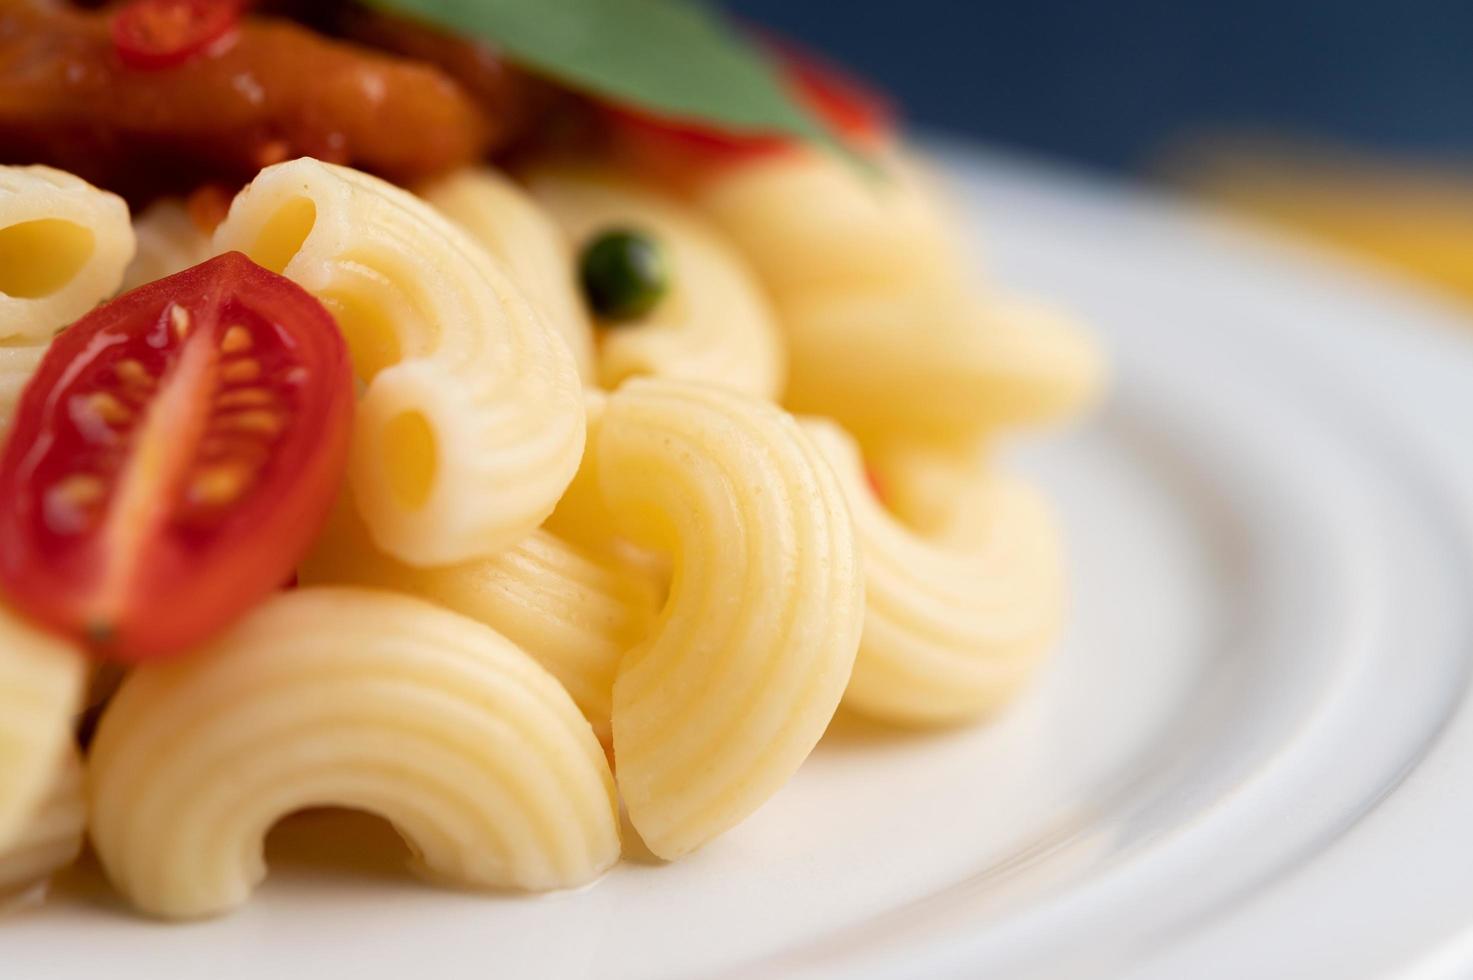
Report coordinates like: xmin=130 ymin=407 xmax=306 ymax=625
xmin=418 ymin=167 xmax=594 ymax=383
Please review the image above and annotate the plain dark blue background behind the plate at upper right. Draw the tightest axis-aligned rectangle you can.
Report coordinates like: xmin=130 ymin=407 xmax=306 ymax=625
xmin=726 ymin=0 xmax=1473 ymax=168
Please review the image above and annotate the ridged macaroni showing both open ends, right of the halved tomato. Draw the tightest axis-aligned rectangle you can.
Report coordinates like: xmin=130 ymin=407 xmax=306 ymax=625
xmin=215 ymin=159 xmax=583 ymax=566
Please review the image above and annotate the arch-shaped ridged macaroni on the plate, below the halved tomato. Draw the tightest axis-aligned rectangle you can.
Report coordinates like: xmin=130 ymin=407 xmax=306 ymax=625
xmin=88 ymin=588 xmax=619 ymax=918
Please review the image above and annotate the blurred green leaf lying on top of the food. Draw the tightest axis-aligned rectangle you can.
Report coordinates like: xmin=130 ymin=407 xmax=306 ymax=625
xmin=368 ymin=0 xmax=851 ymax=148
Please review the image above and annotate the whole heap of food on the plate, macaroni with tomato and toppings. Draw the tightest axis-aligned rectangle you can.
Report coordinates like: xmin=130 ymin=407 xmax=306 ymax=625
xmin=0 ymin=7 xmax=1105 ymax=919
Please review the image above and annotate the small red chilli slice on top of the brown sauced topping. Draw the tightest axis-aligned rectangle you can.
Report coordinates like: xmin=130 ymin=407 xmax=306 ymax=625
xmin=112 ymin=0 xmax=245 ymax=71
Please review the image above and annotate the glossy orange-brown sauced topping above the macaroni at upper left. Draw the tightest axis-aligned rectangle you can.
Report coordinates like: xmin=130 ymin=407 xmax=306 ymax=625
xmin=0 ymin=0 xmax=532 ymax=200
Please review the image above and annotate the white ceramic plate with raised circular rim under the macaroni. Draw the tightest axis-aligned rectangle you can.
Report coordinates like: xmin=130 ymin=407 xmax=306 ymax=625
xmin=11 ymin=149 xmax=1473 ymax=980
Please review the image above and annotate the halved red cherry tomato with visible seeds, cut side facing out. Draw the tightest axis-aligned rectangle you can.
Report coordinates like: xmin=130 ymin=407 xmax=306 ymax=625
xmin=0 ymin=252 xmax=354 ymax=662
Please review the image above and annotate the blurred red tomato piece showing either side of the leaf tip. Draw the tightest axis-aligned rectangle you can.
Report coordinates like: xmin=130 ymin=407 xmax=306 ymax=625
xmin=607 ymin=40 xmax=894 ymax=175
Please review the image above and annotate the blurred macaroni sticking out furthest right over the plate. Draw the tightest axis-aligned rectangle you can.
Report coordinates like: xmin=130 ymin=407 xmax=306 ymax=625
xmin=784 ymin=289 xmax=1105 ymax=448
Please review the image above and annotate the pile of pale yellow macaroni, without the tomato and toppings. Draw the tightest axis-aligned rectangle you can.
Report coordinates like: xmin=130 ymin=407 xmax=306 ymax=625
xmin=0 ymin=141 xmax=1103 ymax=918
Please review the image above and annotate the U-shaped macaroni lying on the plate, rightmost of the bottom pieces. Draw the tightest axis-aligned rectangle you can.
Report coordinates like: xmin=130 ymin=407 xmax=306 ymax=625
xmin=806 ymin=420 xmax=1065 ymax=725
